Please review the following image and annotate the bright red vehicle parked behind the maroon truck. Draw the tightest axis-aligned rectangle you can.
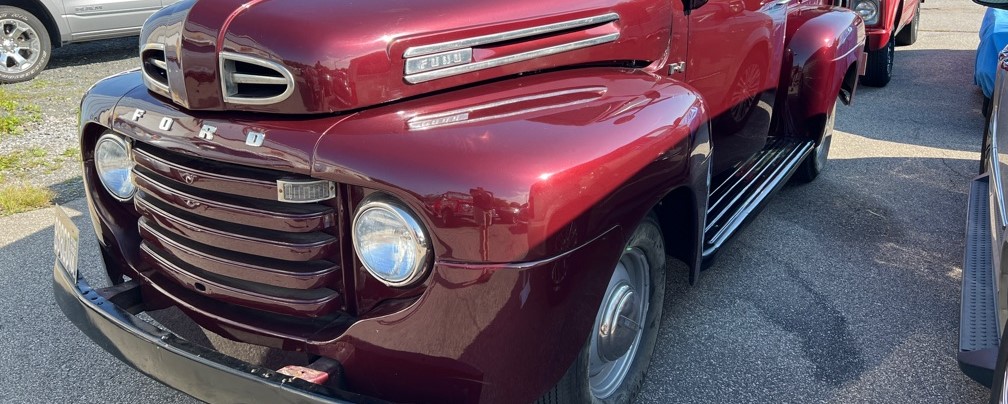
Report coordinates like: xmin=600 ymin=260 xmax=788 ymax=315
xmin=845 ymin=0 xmax=924 ymax=87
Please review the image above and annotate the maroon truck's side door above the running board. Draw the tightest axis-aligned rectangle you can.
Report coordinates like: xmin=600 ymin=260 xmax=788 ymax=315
xmin=685 ymin=0 xmax=797 ymax=175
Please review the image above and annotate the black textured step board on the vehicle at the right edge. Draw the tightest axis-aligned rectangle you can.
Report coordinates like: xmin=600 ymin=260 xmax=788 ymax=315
xmin=956 ymin=175 xmax=1000 ymax=387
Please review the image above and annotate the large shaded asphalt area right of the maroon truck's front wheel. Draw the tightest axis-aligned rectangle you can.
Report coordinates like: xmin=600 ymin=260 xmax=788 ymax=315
xmin=642 ymin=153 xmax=989 ymax=403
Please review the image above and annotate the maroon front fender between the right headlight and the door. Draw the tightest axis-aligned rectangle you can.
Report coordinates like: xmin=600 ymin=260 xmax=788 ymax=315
xmin=312 ymin=68 xmax=711 ymax=402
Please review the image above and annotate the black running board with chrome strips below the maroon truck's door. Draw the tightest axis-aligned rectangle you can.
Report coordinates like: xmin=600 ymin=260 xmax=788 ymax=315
xmin=704 ymin=137 xmax=813 ymax=256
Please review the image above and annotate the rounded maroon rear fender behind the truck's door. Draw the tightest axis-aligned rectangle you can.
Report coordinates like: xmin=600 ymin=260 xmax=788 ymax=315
xmin=774 ymin=7 xmax=865 ymax=141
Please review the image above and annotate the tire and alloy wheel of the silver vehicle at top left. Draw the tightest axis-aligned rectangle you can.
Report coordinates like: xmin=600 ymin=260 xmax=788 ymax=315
xmin=0 ymin=6 xmax=52 ymax=84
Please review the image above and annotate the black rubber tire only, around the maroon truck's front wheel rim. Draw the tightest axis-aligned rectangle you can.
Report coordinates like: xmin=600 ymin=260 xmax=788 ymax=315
xmin=537 ymin=213 xmax=665 ymax=404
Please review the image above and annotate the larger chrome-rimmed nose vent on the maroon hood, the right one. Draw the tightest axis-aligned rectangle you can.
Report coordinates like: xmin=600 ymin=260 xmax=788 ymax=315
xmin=221 ymin=52 xmax=294 ymax=105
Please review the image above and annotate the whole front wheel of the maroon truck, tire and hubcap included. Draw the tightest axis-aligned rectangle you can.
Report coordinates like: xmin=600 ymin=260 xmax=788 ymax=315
xmin=538 ymin=214 xmax=665 ymax=404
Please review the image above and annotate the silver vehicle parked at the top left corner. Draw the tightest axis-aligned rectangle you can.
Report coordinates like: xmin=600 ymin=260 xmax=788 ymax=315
xmin=0 ymin=0 xmax=169 ymax=84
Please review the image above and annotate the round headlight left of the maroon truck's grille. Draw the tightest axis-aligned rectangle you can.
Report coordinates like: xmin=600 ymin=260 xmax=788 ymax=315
xmin=95 ymin=133 xmax=136 ymax=200
